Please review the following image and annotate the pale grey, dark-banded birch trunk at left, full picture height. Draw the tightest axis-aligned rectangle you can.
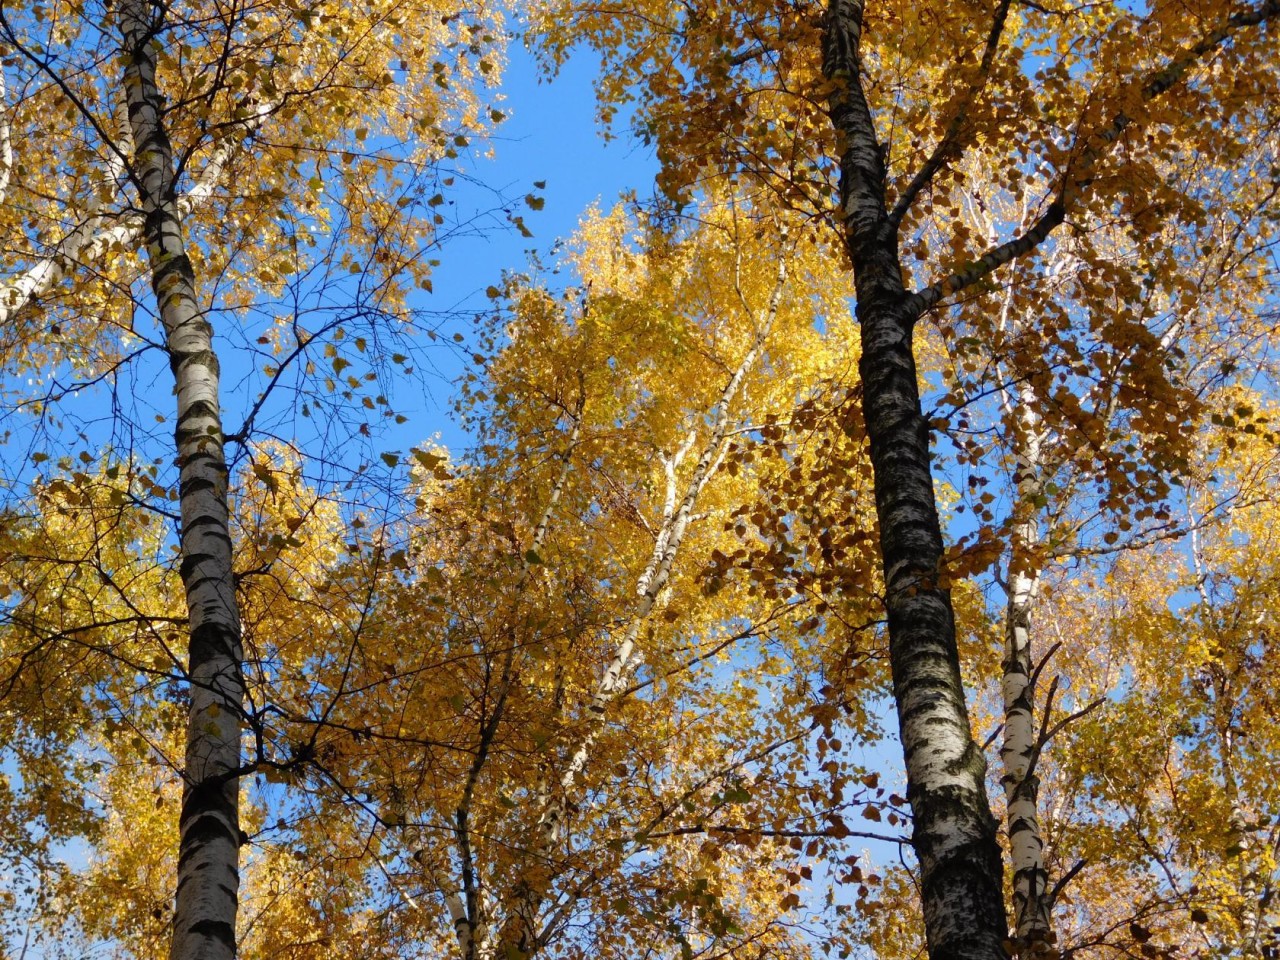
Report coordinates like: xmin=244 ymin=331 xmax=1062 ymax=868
xmin=118 ymin=0 xmax=244 ymax=960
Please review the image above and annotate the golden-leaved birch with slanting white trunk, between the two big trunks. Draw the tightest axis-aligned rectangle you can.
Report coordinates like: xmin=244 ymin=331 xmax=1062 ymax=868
xmin=257 ymin=200 xmax=890 ymax=957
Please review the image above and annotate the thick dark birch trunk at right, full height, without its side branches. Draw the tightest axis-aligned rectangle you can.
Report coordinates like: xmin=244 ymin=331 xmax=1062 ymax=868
xmin=823 ymin=0 xmax=1007 ymax=960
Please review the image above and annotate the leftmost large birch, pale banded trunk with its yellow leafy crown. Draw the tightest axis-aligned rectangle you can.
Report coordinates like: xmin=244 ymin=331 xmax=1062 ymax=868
xmin=0 ymin=3 xmax=498 ymax=959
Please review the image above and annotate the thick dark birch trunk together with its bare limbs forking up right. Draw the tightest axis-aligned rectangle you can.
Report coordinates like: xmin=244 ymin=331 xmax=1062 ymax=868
xmin=823 ymin=3 xmax=1268 ymax=957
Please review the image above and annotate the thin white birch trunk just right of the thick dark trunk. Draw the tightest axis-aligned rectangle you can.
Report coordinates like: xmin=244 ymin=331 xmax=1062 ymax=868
xmin=1000 ymin=387 xmax=1051 ymax=950
